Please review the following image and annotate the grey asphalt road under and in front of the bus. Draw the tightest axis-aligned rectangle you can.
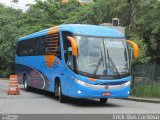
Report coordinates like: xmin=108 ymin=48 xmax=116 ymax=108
xmin=0 ymin=80 xmax=160 ymax=114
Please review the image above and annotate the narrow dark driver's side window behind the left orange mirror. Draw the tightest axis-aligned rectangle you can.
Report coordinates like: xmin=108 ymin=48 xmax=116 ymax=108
xmin=62 ymin=32 xmax=74 ymax=70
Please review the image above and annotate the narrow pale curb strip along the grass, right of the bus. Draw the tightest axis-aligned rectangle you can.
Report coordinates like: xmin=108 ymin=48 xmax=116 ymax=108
xmin=126 ymin=96 xmax=160 ymax=103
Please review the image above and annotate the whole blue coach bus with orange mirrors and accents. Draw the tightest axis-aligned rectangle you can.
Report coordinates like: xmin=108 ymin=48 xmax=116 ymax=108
xmin=15 ymin=24 xmax=138 ymax=103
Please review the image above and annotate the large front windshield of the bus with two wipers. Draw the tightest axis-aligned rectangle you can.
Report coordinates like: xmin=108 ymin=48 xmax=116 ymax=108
xmin=75 ymin=36 xmax=129 ymax=79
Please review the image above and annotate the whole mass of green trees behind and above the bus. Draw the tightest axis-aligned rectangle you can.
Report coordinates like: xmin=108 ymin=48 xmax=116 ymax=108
xmin=0 ymin=0 xmax=160 ymax=75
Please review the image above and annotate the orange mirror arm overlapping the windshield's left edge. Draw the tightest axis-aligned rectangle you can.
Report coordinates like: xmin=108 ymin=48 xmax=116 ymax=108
xmin=67 ymin=36 xmax=77 ymax=56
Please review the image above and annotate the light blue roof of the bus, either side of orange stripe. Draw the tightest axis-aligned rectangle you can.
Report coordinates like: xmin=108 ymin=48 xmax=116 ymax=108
xmin=18 ymin=24 xmax=125 ymax=41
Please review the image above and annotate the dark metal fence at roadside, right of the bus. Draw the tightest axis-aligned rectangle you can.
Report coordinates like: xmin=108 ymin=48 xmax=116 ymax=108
xmin=132 ymin=64 xmax=160 ymax=86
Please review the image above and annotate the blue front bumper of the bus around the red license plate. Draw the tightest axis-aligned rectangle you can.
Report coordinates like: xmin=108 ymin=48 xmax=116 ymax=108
xmin=71 ymin=81 xmax=130 ymax=98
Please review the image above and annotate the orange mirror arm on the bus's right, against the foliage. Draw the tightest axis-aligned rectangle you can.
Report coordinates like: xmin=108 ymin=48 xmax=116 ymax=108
xmin=127 ymin=40 xmax=139 ymax=59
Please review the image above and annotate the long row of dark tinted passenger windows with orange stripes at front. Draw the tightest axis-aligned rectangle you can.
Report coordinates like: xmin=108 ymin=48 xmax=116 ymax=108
xmin=17 ymin=33 xmax=60 ymax=57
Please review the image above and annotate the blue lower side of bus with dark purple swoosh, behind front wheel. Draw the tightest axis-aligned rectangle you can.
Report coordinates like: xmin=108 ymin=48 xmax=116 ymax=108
xmin=16 ymin=56 xmax=63 ymax=92
